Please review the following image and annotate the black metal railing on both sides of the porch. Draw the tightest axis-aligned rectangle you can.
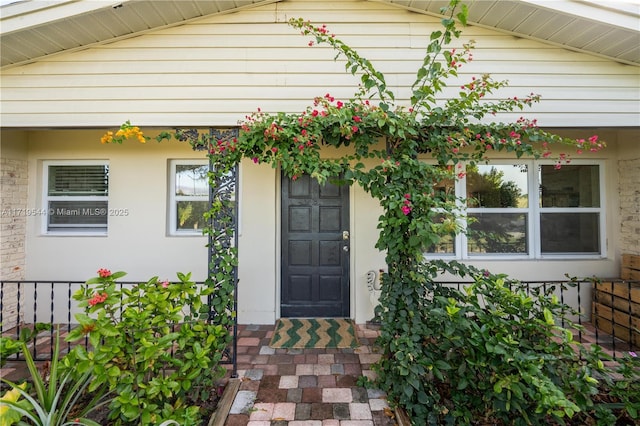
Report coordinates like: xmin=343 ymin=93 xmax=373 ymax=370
xmin=0 ymin=280 xmax=640 ymax=362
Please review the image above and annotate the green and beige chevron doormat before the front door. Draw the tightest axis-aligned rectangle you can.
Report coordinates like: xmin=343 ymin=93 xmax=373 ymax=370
xmin=269 ymin=318 xmax=359 ymax=349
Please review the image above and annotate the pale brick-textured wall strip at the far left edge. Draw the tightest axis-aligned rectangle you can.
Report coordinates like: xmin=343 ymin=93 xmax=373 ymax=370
xmin=0 ymin=157 xmax=28 ymax=330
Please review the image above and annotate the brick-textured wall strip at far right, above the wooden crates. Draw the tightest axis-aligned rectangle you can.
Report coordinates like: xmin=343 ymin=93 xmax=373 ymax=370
xmin=618 ymin=158 xmax=640 ymax=255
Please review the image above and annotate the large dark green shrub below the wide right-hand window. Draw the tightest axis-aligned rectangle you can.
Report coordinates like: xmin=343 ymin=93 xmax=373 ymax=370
xmin=377 ymin=262 xmax=640 ymax=425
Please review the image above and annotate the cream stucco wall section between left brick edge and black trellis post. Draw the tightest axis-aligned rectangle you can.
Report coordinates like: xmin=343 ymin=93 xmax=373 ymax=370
xmin=25 ymin=130 xmax=206 ymax=280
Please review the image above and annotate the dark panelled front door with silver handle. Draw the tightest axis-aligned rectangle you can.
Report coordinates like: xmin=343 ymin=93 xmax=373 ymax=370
xmin=280 ymin=175 xmax=349 ymax=317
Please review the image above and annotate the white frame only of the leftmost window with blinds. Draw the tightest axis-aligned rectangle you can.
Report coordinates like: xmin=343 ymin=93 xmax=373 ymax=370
xmin=40 ymin=160 xmax=111 ymax=237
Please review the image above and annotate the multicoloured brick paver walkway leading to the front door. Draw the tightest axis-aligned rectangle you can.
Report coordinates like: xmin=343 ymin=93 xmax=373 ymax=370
xmin=225 ymin=325 xmax=395 ymax=426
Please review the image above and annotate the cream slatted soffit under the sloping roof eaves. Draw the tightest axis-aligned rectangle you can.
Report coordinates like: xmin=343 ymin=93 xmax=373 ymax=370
xmin=0 ymin=0 xmax=640 ymax=67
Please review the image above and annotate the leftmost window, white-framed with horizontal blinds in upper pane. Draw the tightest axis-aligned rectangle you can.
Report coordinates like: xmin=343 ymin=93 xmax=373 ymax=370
xmin=43 ymin=160 xmax=109 ymax=234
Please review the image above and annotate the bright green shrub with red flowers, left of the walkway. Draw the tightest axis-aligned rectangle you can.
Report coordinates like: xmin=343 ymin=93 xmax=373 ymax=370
xmin=68 ymin=269 xmax=230 ymax=425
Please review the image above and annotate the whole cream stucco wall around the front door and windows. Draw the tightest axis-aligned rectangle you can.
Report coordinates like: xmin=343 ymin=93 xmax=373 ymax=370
xmin=7 ymin=129 xmax=636 ymax=323
